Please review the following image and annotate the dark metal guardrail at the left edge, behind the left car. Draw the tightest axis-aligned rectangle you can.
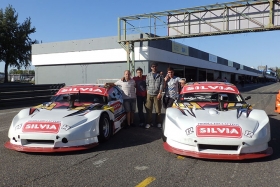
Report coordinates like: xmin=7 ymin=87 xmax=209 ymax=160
xmin=0 ymin=83 xmax=65 ymax=108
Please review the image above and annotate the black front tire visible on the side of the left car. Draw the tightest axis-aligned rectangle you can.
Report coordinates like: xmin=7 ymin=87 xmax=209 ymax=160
xmin=98 ymin=113 xmax=112 ymax=142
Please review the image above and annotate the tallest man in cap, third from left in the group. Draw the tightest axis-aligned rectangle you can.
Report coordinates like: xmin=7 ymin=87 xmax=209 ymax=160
xmin=145 ymin=63 xmax=163 ymax=129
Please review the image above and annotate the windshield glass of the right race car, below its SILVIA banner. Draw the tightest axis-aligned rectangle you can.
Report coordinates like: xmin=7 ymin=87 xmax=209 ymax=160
xmin=178 ymin=92 xmax=245 ymax=103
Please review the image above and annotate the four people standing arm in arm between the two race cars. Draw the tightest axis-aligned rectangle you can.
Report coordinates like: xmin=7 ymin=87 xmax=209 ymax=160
xmin=106 ymin=63 xmax=186 ymax=129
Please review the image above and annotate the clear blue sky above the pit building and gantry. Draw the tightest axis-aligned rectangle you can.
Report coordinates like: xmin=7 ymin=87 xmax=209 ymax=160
xmin=0 ymin=0 xmax=280 ymax=72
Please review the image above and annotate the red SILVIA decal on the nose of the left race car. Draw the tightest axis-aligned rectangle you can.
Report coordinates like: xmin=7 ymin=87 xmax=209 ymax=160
xmin=22 ymin=121 xmax=60 ymax=134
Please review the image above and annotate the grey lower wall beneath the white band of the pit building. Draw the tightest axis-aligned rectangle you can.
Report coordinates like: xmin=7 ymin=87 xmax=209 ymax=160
xmin=35 ymin=61 xmax=150 ymax=85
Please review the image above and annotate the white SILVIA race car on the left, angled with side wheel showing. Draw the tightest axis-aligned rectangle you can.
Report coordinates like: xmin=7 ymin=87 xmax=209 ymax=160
xmin=5 ymin=85 xmax=126 ymax=152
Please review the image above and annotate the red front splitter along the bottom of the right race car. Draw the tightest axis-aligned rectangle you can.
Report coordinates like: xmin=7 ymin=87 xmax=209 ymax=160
xmin=163 ymin=142 xmax=273 ymax=160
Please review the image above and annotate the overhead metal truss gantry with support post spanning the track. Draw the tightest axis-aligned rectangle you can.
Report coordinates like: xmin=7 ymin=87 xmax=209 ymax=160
xmin=118 ymin=0 xmax=280 ymax=75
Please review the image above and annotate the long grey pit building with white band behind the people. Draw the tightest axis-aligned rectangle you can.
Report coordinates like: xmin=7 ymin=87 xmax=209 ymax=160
xmin=32 ymin=35 xmax=260 ymax=85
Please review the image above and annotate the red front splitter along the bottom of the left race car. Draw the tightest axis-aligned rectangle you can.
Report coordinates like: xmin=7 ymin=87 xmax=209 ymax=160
xmin=4 ymin=141 xmax=98 ymax=153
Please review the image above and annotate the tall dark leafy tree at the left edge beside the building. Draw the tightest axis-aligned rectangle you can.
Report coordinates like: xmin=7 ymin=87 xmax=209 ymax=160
xmin=0 ymin=5 xmax=38 ymax=82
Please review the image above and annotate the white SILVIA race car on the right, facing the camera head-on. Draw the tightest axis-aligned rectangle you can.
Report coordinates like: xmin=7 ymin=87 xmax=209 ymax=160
xmin=162 ymin=82 xmax=273 ymax=160
